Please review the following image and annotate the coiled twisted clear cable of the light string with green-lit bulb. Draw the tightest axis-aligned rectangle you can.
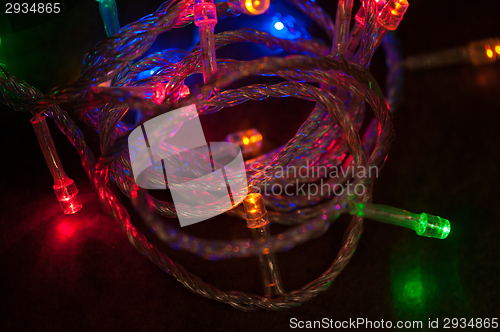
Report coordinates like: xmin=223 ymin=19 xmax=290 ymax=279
xmin=0 ymin=0 xmax=450 ymax=311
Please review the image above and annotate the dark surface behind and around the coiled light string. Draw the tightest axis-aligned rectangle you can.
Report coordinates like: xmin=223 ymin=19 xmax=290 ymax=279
xmin=0 ymin=0 xmax=500 ymax=331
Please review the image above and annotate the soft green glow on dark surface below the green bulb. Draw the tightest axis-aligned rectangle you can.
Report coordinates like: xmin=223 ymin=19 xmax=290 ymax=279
xmin=390 ymin=218 xmax=475 ymax=322
